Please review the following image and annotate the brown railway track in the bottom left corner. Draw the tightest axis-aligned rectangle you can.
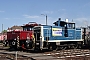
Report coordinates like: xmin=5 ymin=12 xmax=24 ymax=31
xmin=0 ymin=50 xmax=32 ymax=60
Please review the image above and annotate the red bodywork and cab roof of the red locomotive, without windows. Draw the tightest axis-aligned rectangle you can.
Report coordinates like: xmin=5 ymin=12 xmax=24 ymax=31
xmin=7 ymin=22 xmax=41 ymax=40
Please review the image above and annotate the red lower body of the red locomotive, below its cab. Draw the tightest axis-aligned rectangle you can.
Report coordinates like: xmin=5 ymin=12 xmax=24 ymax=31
xmin=7 ymin=31 xmax=33 ymax=40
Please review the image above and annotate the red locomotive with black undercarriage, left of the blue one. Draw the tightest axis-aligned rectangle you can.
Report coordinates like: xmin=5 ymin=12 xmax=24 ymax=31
xmin=7 ymin=22 xmax=41 ymax=49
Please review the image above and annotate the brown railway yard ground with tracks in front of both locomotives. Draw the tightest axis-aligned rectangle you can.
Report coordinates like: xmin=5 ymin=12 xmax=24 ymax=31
xmin=0 ymin=44 xmax=90 ymax=60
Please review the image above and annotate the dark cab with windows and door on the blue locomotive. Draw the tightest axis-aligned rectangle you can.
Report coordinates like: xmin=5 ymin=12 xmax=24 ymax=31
xmin=53 ymin=18 xmax=75 ymax=37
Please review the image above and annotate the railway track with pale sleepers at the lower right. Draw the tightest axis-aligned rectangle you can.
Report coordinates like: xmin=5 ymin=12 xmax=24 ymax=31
xmin=44 ymin=49 xmax=90 ymax=60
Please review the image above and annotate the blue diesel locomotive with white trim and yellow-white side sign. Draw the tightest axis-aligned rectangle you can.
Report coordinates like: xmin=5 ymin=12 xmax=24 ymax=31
xmin=34 ymin=18 xmax=83 ymax=50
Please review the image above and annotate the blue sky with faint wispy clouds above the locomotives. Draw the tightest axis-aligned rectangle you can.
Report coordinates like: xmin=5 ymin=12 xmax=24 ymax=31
xmin=0 ymin=0 xmax=90 ymax=31
